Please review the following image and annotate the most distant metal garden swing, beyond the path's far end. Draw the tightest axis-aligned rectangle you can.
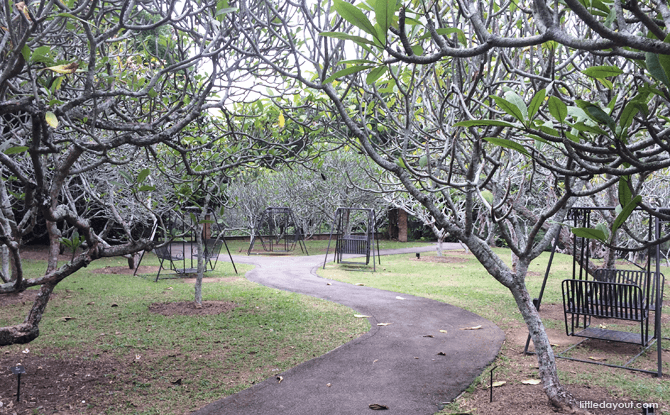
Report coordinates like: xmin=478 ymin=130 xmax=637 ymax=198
xmin=247 ymin=207 xmax=309 ymax=255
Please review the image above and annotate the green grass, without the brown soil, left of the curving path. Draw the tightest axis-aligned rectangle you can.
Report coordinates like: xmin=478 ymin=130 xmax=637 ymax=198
xmin=0 ymin=255 xmax=369 ymax=414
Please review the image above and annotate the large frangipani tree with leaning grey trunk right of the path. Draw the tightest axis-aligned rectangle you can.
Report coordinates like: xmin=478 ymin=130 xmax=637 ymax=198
xmin=227 ymin=0 xmax=670 ymax=409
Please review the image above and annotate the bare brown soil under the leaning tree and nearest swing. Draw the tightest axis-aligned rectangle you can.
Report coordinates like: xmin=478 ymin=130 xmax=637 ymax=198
xmin=458 ymin=304 xmax=670 ymax=415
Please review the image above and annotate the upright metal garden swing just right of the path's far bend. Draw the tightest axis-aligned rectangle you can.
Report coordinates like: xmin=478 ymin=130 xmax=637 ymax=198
xmin=323 ymin=207 xmax=381 ymax=271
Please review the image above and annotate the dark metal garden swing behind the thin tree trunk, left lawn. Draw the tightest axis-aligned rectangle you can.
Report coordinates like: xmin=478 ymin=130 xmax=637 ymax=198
xmin=136 ymin=208 xmax=237 ymax=281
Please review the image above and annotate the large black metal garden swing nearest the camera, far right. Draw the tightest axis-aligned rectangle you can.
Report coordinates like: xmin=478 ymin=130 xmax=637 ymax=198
xmin=525 ymin=207 xmax=665 ymax=377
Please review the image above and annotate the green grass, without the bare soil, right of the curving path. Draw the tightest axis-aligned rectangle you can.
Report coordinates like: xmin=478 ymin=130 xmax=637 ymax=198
xmin=318 ymin=249 xmax=670 ymax=413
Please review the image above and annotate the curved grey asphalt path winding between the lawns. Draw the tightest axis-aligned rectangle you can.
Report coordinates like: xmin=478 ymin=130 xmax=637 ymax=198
xmin=195 ymin=244 xmax=505 ymax=415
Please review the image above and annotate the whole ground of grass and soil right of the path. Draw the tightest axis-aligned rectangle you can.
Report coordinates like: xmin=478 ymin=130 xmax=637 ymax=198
xmin=318 ymin=248 xmax=670 ymax=415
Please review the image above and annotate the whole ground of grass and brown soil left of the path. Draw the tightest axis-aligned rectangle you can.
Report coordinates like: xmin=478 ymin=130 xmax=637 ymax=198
xmin=0 ymin=252 xmax=369 ymax=414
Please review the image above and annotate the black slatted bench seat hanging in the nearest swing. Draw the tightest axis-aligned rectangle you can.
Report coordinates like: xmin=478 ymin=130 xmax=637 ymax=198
xmin=562 ymin=269 xmax=665 ymax=347
